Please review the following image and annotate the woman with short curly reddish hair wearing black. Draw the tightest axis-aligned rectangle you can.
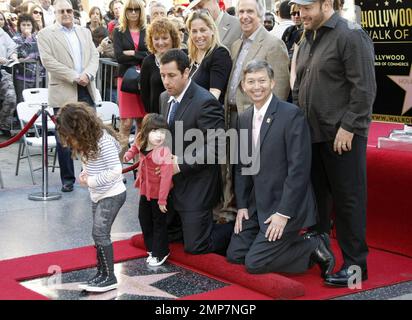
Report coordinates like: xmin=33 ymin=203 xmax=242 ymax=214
xmin=140 ymin=18 xmax=180 ymax=113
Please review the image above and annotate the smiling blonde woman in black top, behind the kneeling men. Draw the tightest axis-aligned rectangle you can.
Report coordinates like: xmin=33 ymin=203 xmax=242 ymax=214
xmin=186 ymin=10 xmax=232 ymax=105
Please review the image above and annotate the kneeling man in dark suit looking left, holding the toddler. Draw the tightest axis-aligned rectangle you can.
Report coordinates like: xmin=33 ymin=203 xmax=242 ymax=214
xmin=160 ymin=49 xmax=233 ymax=254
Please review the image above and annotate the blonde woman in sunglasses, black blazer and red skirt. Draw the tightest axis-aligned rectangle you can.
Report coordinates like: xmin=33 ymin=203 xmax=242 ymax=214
xmin=113 ymin=0 xmax=148 ymax=159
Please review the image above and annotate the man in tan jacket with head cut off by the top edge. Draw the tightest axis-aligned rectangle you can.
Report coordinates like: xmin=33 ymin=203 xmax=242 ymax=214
xmin=187 ymin=0 xmax=242 ymax=50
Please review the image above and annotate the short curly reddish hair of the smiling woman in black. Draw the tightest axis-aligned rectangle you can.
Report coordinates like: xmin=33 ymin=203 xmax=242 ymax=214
xmin=146 ymin=18 xmax=181 ymax=54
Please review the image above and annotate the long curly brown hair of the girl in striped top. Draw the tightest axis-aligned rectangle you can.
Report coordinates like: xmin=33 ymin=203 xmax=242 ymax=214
xmin=56 ymin=102 xmax=118 ymax=162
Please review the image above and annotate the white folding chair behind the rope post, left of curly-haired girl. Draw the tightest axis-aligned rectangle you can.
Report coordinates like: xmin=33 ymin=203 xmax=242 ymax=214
xmin=16 ymin=102 xmax=56 ymax=184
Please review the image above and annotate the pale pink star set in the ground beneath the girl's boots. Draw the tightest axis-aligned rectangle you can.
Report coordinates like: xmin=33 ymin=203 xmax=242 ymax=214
xmin=27 ymin=272 xmax=178 ymax=300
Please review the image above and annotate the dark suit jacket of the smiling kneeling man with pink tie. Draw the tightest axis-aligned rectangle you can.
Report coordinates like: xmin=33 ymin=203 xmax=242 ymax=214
xmin=235 ymin=96 xmax=316 ymax=232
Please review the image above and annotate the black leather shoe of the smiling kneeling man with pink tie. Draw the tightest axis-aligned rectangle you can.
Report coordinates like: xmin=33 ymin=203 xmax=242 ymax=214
xmin=309 ymin=233 xmax=335 ymax=278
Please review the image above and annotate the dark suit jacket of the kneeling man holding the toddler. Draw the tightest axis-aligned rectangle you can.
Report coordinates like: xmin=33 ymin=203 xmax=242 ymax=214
xmin=160 ymin=81 xmax=225 ymax=211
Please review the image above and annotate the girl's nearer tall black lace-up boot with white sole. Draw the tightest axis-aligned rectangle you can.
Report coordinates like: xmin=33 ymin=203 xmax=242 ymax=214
xmin=85 ymin=244 xmax=118 ymax=292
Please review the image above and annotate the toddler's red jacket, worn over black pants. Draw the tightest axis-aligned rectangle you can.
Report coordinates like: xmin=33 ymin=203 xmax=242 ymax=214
xmin=126 ymin=144 xmax=173 ymax=205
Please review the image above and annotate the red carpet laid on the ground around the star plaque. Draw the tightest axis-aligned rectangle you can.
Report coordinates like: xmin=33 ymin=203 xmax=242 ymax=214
xmin=0 ymin=235 xmax=412 ymax=300
